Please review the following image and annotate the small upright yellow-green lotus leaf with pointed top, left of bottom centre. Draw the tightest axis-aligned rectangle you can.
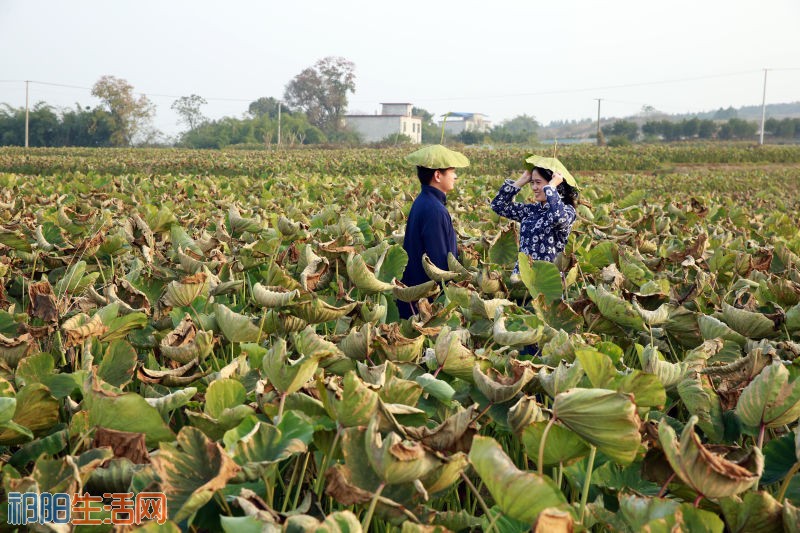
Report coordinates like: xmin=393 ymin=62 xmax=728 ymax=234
xmin=317 ymin=371 xmax=380 ymax=427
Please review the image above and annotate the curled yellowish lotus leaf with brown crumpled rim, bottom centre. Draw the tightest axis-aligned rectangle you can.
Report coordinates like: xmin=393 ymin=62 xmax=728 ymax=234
xmin=364 ymin=417 xmax=440 ymax=485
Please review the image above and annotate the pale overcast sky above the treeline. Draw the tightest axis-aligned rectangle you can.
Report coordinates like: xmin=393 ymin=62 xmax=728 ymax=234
xmin=0 ymin=0 xmax=800 ymax=134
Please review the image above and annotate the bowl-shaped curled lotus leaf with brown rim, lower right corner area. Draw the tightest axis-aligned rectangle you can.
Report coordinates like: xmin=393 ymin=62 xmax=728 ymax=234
xmin=658 ymin=416 xmax=764 ymax=498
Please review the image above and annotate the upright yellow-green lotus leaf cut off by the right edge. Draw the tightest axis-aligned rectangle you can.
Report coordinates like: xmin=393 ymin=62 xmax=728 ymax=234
xmin=736 ymin=361 xmax=800 ymax=428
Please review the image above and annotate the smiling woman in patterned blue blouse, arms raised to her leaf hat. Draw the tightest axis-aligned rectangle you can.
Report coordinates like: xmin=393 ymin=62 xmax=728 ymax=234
xmin=492 ymin=167 xmax=578 ymax=274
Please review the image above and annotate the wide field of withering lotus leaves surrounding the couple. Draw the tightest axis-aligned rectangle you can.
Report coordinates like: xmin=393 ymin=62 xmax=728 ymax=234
xmin=0 ymin=145 xmax=800 ymax=533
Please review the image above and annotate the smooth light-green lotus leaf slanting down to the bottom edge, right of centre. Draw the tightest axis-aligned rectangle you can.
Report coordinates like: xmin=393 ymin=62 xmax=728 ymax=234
xmin=469 ymin=436 xmax=566 ymax=524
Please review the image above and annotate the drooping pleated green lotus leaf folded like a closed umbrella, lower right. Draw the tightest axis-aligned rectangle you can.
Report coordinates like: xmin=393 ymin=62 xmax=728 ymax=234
xmin=553 ymin=389 xmax=641 ymax=464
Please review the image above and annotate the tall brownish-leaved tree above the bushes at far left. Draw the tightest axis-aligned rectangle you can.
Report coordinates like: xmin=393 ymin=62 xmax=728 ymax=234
xmin=92 ymin=76 xmax=155 ymax=146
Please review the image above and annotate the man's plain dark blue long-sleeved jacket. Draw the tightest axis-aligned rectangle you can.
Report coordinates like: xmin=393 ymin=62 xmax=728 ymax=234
xmin=397 ymin=185 xmax=458 ymax=318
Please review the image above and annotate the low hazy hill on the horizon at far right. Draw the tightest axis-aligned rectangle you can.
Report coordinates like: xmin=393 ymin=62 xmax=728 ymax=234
xmin=538 ymin=102 xmax=800 ymax=139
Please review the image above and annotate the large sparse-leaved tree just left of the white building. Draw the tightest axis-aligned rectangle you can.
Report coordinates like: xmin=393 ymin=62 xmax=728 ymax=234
xmin=284 ymin=56 xmax=356 ymax=132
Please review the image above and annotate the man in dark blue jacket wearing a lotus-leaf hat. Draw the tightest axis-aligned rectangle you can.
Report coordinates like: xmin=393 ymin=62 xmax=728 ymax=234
xmin=397 ymin=144 xmax=469 ymax=318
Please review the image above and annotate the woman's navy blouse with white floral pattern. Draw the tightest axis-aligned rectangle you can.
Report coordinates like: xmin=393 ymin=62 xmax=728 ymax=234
xmin=492 ymin=180 xmax=576 ymax=272
